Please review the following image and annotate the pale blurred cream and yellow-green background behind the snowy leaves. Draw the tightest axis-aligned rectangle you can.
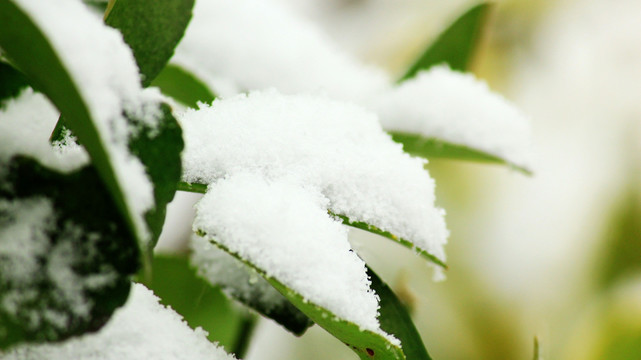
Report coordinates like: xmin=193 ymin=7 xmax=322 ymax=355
xmin=156 ymin=0 xmax=641 ymax=360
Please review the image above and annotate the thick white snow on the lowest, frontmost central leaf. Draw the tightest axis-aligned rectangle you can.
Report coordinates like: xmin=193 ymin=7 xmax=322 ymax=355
xmin=194 ymin=173 xmax=396 ymax=342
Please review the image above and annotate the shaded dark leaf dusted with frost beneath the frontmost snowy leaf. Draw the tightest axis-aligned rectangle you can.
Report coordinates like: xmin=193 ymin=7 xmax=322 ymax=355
xmin=191 ymin=235 xmax=313 ymax=335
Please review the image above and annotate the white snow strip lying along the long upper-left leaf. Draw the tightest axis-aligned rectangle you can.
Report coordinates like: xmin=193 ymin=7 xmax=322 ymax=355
xmin=16 ymin=0 xmax=160 ymax=245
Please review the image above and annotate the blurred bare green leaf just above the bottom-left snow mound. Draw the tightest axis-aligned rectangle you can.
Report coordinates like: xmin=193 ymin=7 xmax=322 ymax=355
xmin=148 ymin=255 xmax=246 ymax=352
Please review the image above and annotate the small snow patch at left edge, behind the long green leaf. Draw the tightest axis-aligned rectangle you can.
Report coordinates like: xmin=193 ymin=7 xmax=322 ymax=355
xmin=0 ymin=88 xmax=89 ymax=172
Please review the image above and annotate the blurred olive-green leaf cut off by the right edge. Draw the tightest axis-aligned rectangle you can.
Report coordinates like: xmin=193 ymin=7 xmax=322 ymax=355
xmin=600 ymin=189 xmax=641 ymax=287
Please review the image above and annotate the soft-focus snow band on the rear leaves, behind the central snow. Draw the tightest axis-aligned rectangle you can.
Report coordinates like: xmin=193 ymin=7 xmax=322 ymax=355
xmin=172 ymin=0 xmax=531 ymax=167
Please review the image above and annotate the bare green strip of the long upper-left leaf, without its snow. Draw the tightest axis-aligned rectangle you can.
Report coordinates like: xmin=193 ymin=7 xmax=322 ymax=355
xmin=0 ymin=0 xmax=142 ymax=252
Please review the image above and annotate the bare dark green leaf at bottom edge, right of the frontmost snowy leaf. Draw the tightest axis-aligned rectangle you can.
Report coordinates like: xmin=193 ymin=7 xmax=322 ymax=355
xmin=367 ymin=267 xmax=431 ymax=360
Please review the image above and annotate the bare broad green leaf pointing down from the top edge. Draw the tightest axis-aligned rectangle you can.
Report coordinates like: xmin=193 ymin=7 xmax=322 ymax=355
xmin=105 ymin=0 xmax=194 ymax=86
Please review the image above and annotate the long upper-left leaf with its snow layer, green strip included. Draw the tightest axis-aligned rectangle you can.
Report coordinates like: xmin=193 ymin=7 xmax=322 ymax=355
xmin=0 ymin=0 xmax=162 ymax=246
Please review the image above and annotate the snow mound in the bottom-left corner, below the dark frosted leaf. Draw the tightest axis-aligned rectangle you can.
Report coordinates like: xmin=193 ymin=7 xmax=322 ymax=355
xmin=0 ymin=284 xmax=234 ymax=360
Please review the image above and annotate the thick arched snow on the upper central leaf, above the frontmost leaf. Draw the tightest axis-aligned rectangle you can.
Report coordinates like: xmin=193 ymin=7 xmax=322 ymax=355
xmin=179 ymin=91 xmax=448 ymax=259
